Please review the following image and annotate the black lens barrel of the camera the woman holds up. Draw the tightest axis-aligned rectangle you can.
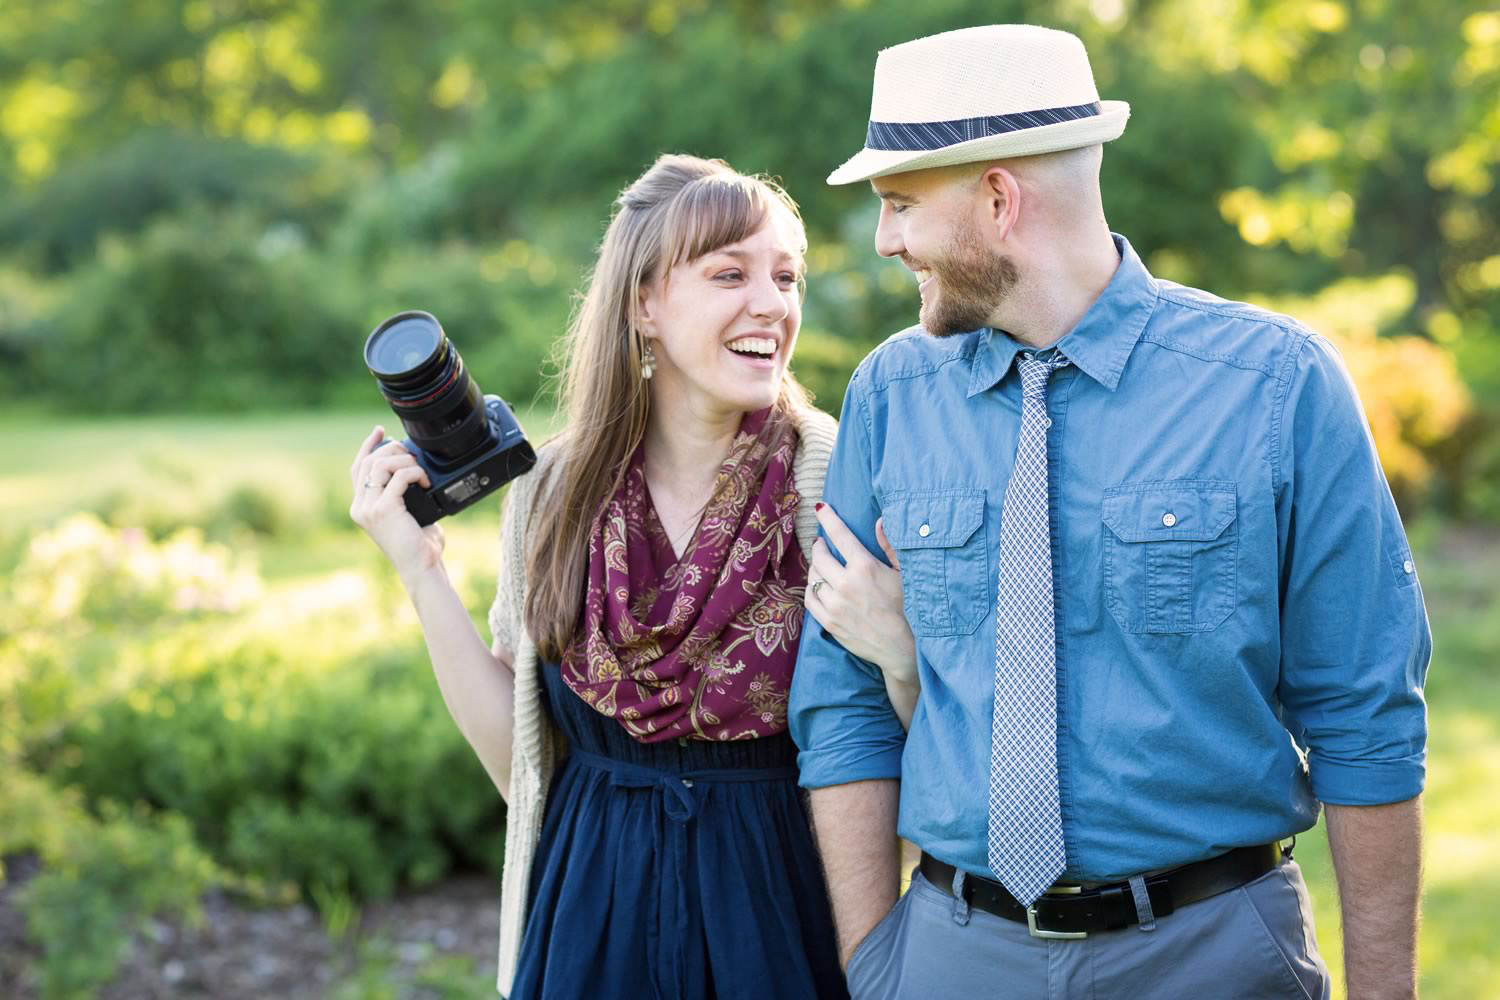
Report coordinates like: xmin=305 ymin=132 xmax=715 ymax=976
xmin=365 ymin=310 xmax=491 ymax=465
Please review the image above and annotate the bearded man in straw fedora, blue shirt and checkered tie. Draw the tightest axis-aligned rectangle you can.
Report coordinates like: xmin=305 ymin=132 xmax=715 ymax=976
xmin=791 ymin=25 xmax=1431 ymax=999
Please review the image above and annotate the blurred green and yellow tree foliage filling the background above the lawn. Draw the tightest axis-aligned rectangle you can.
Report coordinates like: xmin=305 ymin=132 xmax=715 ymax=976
xmin=0 ymin=0 xmax=1500 ymax=507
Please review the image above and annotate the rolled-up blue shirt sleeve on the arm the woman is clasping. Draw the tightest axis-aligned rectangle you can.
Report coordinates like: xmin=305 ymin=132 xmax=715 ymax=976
xmin=789 ymin=372 xmax=906 ymax=789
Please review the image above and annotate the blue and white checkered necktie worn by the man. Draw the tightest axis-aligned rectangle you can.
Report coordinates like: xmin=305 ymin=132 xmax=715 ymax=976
xmin=989 ymin=354 xmax=1068 ymax=906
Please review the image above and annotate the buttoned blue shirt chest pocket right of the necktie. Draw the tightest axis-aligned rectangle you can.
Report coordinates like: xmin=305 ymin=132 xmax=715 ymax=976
xmin=1101 ymin=480 xmax=1239 ymax=633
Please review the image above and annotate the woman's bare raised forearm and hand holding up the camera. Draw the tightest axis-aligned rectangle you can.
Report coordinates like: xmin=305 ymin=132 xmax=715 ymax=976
xmin=350 ymin=427 xmax=516 ymax=796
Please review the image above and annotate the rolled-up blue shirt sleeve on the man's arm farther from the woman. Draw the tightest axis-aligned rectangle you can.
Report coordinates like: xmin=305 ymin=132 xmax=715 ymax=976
xmin=1277 ymin=334 xmax=1433 ymax=805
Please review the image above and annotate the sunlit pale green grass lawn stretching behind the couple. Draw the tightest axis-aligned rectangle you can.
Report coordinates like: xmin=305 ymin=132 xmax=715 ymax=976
xmin=0 ymin=408 xmax=1500 ymax=1000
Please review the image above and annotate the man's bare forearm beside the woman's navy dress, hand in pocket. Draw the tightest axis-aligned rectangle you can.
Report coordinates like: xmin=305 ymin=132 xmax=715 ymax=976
xmin=810 ymin=781 xmax=902 ymax=966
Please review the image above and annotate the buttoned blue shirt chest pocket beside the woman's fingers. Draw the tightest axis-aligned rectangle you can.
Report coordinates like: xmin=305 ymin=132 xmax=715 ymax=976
xmin=882 ymin=489 xmax=992 ymax=636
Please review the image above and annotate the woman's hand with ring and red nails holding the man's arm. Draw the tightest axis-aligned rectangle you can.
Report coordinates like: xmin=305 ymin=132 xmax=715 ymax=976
xmin=806 ymin=504 xmax=920 ymax=724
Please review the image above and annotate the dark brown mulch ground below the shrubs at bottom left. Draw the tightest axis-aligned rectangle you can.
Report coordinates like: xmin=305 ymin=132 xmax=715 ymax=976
xmin=0 ymin=856 xmax=500 ymax=1000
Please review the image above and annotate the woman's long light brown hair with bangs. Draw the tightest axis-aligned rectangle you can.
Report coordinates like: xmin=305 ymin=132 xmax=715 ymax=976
xmin=525 ymin=154 xmax=809 ymax=660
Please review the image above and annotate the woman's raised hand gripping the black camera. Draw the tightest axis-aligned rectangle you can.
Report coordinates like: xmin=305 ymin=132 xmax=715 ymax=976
xmin=350 ymin=427 xmax=443 ymax=580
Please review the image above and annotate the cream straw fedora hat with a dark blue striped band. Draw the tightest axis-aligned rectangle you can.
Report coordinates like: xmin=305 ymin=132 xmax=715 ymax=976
xmin=828 ymin=24 xmax=1130 ymax=184
